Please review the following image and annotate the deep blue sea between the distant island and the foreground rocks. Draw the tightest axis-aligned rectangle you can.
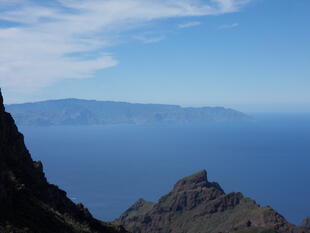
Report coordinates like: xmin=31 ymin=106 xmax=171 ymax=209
xmin=20 ymin=114 xmax=310 ymax=223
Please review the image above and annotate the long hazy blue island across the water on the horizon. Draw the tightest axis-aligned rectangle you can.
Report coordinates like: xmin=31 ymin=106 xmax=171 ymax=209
xmin=6 ymin=99 xmax=250 ymax=126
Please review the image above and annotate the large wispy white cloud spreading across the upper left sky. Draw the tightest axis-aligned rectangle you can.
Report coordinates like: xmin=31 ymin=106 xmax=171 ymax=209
xmin=0 ymin=0 xmax=252 ymax=91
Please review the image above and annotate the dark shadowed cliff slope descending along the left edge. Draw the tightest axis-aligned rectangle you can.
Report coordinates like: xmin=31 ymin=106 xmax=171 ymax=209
xmin=0 ymin=89 xmax=126 ymax=233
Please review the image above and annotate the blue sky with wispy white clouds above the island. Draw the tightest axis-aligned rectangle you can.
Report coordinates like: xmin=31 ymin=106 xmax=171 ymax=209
xmin=0 ymin=0 xmax=310 ymax=112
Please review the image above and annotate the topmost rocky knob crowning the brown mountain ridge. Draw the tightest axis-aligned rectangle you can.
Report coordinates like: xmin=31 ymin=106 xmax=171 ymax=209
xmin=173 ymin=170 xmax=224 ymax=194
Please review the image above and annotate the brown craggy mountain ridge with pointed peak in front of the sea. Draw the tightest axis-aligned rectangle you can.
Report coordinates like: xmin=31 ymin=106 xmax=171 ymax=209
xmin=116 ymin=171 xmax=310 ymax=233
